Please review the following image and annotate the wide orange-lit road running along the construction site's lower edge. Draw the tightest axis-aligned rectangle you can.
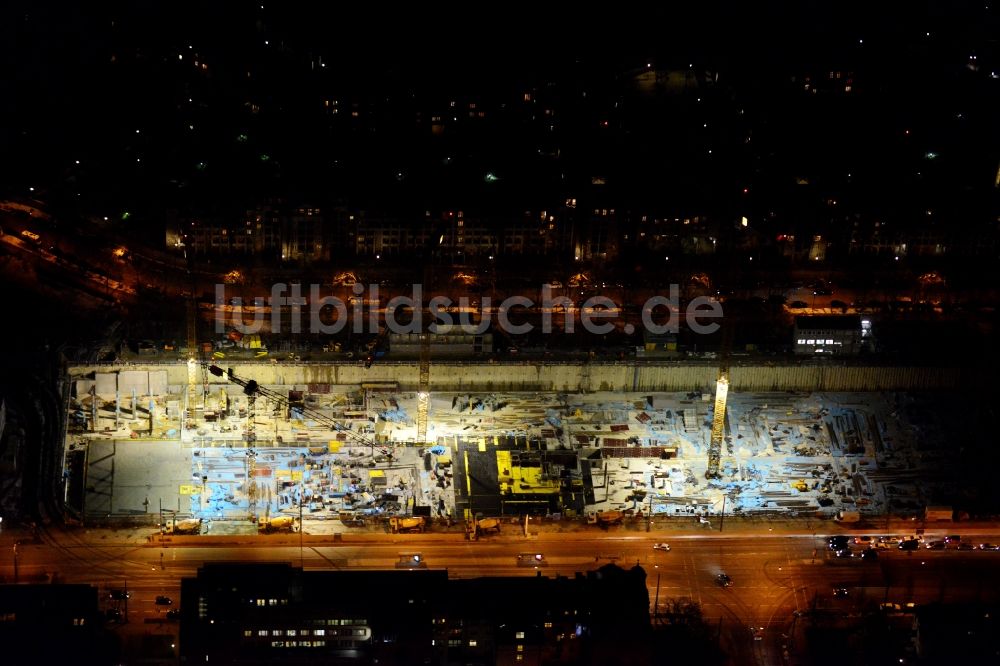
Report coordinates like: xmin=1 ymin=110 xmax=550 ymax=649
xmin=0 ymin=530 xmax=1000 ymax=663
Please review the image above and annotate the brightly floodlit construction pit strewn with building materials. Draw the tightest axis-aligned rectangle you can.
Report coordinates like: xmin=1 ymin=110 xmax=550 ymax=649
xmin=65 ymin=365 xmax=968 ymax=532
